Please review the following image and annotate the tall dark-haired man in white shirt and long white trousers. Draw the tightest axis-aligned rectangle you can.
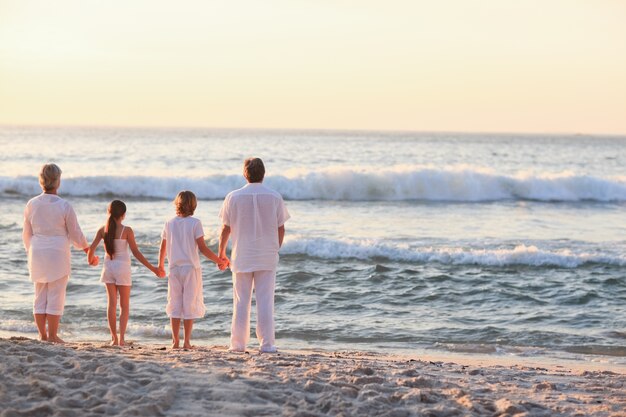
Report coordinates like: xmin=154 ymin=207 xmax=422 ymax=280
xmin=219 ymin=158 xmax=290 ymax=352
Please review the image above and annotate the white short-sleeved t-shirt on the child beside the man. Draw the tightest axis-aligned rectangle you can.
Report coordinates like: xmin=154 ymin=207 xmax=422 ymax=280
xmin=161 ymin=216 xmax=204 ymax=274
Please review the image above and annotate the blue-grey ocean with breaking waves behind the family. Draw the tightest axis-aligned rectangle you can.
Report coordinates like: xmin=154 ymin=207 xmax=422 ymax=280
xmin=0 ymin=126 xmax=626 ymax=365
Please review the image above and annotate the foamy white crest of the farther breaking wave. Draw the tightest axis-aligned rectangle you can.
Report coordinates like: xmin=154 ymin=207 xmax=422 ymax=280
xmin=0 ymin=166 xmax=626 ymax=202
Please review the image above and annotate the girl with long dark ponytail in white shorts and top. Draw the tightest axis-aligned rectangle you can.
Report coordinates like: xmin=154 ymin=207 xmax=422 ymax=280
xmin=87 ymin=200 xmax=164 ymax=346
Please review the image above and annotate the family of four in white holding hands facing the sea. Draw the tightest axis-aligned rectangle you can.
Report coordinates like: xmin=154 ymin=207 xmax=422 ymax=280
xmin=23 ymin=158 xmax=290 ymax=352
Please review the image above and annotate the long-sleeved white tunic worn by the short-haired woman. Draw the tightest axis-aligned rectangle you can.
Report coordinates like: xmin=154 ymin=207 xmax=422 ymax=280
xmin=22 ymin=193 xmax=89 ymax=282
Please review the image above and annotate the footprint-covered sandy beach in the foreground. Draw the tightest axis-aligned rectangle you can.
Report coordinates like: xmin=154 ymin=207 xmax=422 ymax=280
xmin=0 ymin=337 xmax=626 ymax=417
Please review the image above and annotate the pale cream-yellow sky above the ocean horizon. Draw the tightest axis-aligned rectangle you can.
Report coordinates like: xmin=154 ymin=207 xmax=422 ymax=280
xmin=0 ymin=0 xmax=626 ymax=134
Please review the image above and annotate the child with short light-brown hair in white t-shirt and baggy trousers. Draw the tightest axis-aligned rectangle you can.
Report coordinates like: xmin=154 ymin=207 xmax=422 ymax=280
xmin=159 ymin=191 xmax=228 ymax=349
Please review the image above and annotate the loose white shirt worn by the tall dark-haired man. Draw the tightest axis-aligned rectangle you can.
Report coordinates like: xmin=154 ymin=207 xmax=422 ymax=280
xmin=220 ymin=183 xmax=290 ymax=272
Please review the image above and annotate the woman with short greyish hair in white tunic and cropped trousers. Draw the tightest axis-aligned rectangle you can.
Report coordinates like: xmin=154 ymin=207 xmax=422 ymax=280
xmin=22 ymin=164 xmax=99 ymax=343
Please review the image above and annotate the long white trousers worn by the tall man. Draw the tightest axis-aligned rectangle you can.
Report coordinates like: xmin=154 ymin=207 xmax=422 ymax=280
xmin=230 ymin=271 xmax=276 ymax=352
